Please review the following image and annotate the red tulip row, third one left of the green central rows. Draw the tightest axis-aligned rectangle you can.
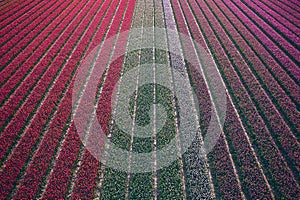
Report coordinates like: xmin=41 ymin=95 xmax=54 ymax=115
xmin=10 ymin=0 xmax=113 ymax=198
